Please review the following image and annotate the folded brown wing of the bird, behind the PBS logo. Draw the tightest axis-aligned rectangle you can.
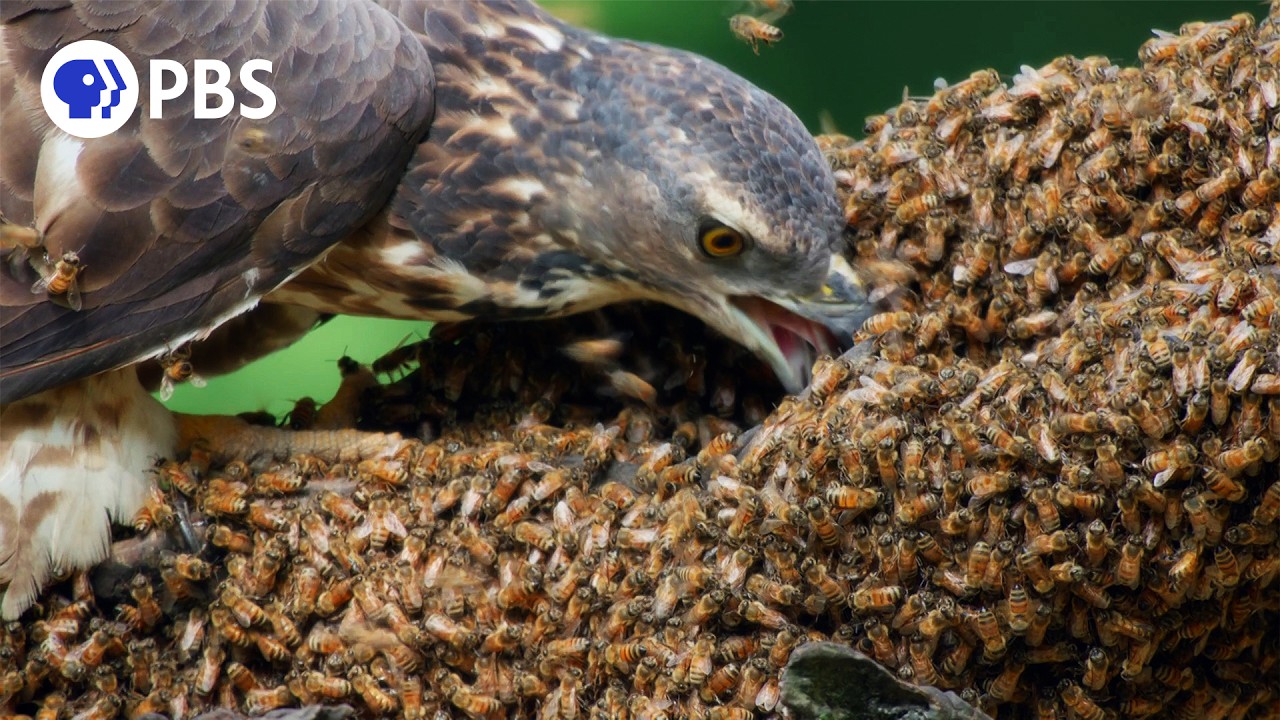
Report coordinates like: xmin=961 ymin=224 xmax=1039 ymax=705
xmin=0 ymin=0 xmax=434 ymax=402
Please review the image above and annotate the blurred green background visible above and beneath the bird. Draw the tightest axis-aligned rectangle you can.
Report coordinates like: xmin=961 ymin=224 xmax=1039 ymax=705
xmin=157 ymin=0 xmax=1249 ymax=415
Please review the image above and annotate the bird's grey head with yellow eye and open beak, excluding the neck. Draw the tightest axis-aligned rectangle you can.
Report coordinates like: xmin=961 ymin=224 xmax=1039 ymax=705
xmin=549 ymin=35 xmax=868 ymax=391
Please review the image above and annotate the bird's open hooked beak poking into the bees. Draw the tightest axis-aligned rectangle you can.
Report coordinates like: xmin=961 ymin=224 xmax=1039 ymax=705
xmin=722 ymin=255 xmax=870 ymax=392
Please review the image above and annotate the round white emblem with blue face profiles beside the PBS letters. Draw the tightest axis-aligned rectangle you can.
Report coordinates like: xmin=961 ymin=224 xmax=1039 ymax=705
xmin=40 ymin=40 xmax=138 ymax=138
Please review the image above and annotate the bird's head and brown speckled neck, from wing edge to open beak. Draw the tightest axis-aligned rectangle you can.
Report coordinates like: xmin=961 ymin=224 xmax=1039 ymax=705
xmin=290 ymin=3 xmax=868 ymax=391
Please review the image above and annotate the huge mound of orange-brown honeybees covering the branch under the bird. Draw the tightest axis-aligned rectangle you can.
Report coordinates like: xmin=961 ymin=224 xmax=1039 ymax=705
xmin=0 ymin=8 xmax=1280 ymax=720
